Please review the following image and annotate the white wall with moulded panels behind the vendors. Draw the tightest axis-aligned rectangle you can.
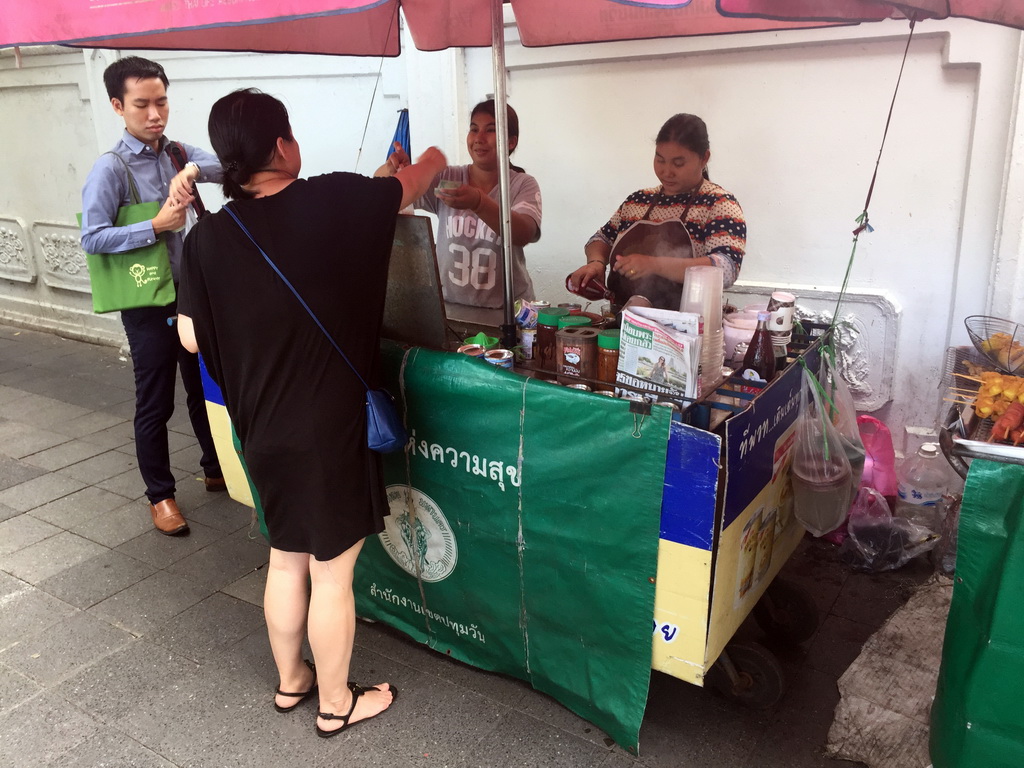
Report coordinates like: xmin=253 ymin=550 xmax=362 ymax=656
xmin=0 ymin=13 xmax=1024 ymax=447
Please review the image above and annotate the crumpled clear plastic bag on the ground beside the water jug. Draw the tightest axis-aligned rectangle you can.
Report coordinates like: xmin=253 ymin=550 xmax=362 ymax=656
xmin=840 ymin=486 xmax=939 ymax=571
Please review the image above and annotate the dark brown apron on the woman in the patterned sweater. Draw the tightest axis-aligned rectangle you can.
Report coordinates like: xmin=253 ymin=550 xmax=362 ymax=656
xmin=608 ymin=196 xmax=693 ymax=311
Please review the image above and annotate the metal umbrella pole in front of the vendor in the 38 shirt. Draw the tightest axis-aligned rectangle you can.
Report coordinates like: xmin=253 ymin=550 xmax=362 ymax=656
xmin=490 ymin=0 xmax=516 ymax=349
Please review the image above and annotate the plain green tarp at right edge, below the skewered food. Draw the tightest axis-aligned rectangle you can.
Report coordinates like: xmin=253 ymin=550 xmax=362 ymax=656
xmin=930 ymin=459 xmax=1024 ymax=768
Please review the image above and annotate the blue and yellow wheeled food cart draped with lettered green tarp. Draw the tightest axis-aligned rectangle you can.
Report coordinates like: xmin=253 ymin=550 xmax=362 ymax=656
xmin=206 ymin=216 xmax=818 ymax=746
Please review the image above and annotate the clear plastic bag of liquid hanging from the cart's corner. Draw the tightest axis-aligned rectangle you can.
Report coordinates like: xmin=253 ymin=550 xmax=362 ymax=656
xmin=792 ymin=370 xmax=854 ymax=537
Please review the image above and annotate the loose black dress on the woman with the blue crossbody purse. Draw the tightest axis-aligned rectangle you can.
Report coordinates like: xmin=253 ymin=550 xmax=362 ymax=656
xmin=178 ymin=173 xmax=401 ymax=560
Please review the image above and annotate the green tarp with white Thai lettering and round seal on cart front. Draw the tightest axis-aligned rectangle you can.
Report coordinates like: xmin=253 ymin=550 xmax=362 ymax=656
xmin=355 ymin=345 xmax=671 ymax=749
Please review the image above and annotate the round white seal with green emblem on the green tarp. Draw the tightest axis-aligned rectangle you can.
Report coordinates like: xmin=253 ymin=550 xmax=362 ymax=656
xmin=379 ymin=485 xmax=459 ymax=582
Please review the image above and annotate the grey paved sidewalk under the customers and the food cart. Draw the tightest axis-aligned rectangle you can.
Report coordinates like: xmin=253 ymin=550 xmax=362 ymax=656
xmin=0 ymin=325 xmax=942 ymax=768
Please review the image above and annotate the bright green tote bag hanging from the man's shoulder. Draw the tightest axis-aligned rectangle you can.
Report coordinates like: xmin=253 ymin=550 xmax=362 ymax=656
xmin=78 ymin=152 xmax=175 ymax=312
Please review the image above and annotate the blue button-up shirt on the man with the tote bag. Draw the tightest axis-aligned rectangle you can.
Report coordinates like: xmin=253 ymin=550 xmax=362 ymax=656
xmin=82 ymin=130 xmax=222 ymax=283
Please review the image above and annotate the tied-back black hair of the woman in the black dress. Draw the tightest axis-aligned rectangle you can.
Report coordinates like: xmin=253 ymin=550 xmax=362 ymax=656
xmin=207 ymin=88 xmax=293 ymax=200
